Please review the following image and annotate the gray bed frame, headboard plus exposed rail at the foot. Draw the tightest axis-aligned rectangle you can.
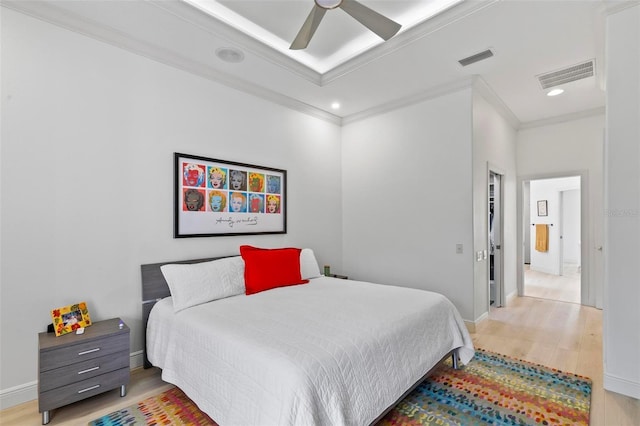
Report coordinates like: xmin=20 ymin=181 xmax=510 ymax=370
xmin=140 ymin=256 xmax=458 ymax=425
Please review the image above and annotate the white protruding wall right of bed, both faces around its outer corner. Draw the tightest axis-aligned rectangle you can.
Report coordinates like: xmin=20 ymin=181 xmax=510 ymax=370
xmin=343 ymin=84 xmax=516 ymax=322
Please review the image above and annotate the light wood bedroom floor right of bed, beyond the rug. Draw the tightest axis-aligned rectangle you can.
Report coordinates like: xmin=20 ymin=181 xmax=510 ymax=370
xmin=472 ymin=297 xmax=640 ymax=426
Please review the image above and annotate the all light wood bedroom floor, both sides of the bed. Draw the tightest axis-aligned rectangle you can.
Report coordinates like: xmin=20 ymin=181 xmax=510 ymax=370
xmin=0 ymin=297 xmax=640 ymax=426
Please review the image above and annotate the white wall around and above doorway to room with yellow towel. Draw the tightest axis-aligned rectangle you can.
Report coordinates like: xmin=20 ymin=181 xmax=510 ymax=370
xmin=516 ymin=115 xmax=604 ymax=307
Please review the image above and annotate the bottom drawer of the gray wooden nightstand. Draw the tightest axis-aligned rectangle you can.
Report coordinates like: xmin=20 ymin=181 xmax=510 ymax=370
xmin=38 ymin=366 xmax=129 ymax=412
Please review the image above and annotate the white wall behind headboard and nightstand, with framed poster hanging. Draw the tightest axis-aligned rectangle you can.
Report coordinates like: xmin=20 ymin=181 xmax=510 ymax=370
xmin=0 ymin=8 xmax=342 ymax=404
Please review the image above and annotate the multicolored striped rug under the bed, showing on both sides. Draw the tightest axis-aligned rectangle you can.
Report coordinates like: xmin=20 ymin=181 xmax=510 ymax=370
xmin=89 ymin=349 xmax=591 ymax=426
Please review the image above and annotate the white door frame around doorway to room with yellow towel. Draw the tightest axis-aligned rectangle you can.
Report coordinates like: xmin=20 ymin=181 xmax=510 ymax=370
xmin=516 ymin=170 xmax=596 ymax=306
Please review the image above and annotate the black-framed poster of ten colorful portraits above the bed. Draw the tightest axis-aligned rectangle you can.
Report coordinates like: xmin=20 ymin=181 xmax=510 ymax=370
xmin=173 ymin=152 xmax=287 ymax=238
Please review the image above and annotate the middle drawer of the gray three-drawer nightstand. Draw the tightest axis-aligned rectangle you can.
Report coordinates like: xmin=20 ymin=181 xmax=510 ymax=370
xmin=38 ymin=351 xmax=129 ymax=392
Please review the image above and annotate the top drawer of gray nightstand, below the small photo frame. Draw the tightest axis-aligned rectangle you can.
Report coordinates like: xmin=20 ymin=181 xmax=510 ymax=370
xmin=40 ymin=333 xmax=129 ymax=372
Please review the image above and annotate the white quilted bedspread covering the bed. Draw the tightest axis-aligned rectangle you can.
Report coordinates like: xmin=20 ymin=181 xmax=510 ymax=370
xmin=147 ymin=277 xmax=474 ymax=426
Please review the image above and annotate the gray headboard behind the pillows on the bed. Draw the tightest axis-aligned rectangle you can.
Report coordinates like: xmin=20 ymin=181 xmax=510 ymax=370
xmin=140 ymin=256 xmax=230 ymax=368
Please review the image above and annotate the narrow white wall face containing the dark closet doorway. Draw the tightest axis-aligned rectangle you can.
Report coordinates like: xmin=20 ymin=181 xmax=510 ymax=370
xmin=473 ymin=87 xmax=517 ymax=320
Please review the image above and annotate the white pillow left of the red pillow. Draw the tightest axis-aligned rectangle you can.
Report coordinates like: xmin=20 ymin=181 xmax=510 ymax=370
xmin=160 ymin=256 xmax=245 ymax=312
